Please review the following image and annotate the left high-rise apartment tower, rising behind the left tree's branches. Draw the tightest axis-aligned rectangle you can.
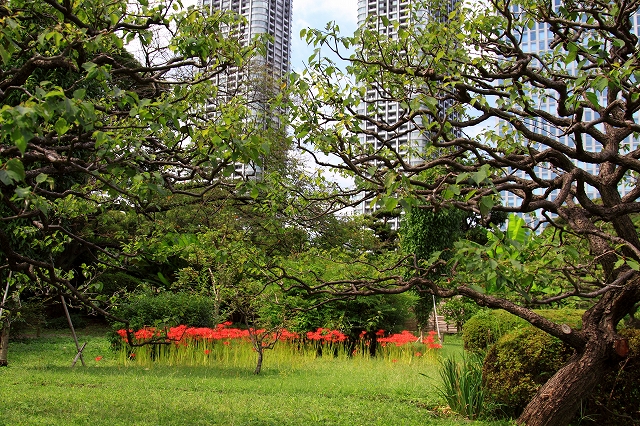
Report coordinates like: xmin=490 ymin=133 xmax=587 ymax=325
xmin=200 ymin=0 xmax=292 ymax=177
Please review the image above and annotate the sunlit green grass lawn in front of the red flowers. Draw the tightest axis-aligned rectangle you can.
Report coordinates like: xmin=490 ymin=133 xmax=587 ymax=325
xmin=0 ymin=333 xmax=504 ymax=425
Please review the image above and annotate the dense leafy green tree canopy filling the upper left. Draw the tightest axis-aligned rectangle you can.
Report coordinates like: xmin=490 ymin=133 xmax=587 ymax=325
xmin=0 ymin=0 xmax=268 ymax=312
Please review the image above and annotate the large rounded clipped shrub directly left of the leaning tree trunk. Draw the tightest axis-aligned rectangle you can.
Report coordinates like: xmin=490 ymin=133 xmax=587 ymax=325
xmin=482 ymin=326 xmax=573 ymax=417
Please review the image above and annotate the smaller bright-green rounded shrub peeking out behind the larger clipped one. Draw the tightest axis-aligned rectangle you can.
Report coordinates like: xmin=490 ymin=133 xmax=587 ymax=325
xmin=462 ymin=309 xmax=526 ymax=352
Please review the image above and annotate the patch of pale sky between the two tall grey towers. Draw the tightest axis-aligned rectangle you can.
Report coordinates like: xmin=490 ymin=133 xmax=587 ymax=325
xmin=291 ymin=0 xmax=358 ymax=71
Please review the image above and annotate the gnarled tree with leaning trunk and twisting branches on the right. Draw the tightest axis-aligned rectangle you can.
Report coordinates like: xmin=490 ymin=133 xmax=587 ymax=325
xmin=293 ymin=0 xmax=640 ymax=424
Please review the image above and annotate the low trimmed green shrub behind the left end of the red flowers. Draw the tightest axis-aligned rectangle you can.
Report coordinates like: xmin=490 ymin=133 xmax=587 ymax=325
xmin=114 ymin=292 xmax=218 ymax=330
